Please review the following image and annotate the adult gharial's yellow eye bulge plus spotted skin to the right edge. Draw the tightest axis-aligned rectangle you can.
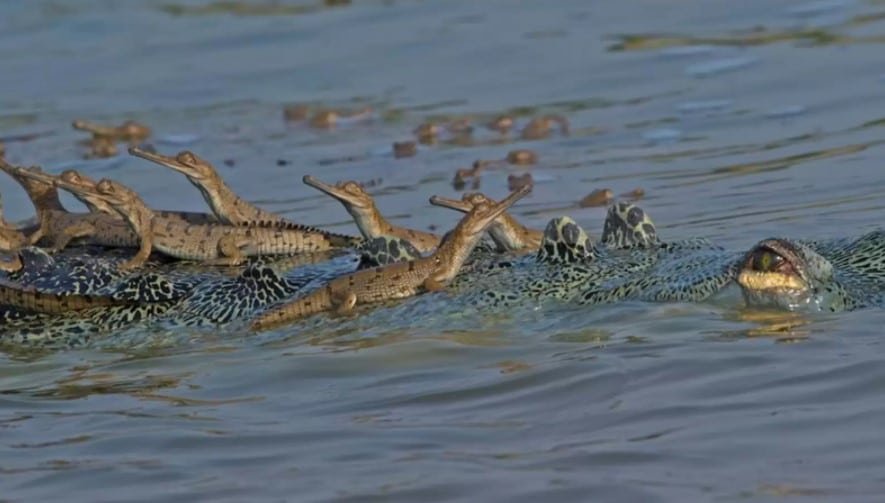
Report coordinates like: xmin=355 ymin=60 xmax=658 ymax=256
xmin=737 ymin=230 xmax=885 ymax=311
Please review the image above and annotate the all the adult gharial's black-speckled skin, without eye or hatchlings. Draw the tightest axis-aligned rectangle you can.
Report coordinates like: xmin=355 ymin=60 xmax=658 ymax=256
xmin=0 ymin=203 xmax=885 ymax=348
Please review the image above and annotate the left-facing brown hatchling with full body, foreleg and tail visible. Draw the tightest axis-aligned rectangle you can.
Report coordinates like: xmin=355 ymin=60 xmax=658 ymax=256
xmin=64 ymin=179 xmax=359 ymax=269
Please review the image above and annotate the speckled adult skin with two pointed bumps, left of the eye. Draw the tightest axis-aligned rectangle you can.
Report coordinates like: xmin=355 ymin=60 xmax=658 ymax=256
xmin=442 ymin=204 xmax=739 ymax=309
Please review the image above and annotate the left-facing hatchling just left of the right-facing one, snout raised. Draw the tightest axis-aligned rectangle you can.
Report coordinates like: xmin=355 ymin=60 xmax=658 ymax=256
xmin=304 ymin=175 xmax=440 ymax=253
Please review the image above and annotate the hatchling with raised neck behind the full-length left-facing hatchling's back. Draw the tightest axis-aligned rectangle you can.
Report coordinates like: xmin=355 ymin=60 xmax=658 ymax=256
xmin=129 ymin=147 xmax=288 ymax=225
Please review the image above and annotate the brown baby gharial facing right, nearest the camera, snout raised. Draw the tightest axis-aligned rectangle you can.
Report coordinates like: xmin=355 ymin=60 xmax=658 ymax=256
xmin=245 ymin=183 xmax=530 ymax=330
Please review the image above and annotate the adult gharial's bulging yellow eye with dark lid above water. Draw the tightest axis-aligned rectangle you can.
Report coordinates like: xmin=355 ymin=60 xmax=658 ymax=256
xmin=737 ymin=239 xmax=853 ymax=311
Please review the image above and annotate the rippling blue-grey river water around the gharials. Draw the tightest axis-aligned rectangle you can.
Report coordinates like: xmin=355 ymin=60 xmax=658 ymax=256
xmin=0 ymin=0 xmax=885 ymax=502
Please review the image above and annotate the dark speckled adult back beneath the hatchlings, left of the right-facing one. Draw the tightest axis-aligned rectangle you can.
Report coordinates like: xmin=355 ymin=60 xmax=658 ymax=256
xmin=0 ymin=256 xmax=352 ymax=348
